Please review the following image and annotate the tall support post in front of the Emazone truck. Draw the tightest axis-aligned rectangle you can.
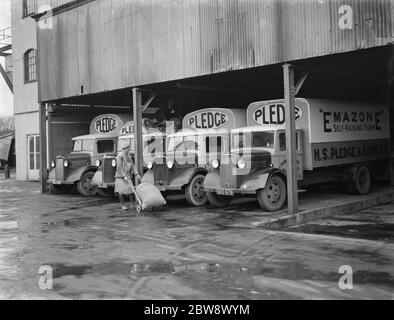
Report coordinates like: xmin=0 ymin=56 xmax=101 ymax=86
xmin=282 ymin=63 xmax=298 ymax=214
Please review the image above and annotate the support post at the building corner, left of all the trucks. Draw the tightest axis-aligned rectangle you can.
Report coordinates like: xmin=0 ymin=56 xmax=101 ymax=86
xmin=39 ymin=102 xmax=48 ymax=193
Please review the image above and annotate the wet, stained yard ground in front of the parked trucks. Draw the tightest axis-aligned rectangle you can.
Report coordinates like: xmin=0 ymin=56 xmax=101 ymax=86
xmin=0 ymin=178 xmax=394 ymax=299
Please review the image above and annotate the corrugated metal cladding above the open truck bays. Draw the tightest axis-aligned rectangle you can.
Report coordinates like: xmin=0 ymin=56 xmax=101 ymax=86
xmin=39 ymin=0 xmax=394 ymax=101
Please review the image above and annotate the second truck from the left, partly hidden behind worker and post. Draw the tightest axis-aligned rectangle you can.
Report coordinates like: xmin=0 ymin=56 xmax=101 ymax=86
xmin=92 ymin=121 xmax=165 ymax=196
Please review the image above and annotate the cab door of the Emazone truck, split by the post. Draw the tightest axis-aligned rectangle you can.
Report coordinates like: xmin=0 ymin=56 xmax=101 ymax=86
xmin=275 ymin=130 xmax=304 ymax=180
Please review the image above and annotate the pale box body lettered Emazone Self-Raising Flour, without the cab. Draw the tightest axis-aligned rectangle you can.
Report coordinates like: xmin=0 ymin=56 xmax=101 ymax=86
xmin=247 ymin=98 xmax=390 ymax=170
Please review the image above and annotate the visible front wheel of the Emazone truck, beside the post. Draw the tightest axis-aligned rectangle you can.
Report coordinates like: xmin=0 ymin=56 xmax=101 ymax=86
xmin=257 ymin=175 xmax=287 ymax=211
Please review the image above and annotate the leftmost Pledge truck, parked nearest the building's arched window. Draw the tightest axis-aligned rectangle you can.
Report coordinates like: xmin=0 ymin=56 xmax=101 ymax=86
xmin=48 ymin=114 xmax=132 ymax=197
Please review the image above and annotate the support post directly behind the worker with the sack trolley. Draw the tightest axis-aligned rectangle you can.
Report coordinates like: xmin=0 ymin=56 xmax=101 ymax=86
xmin=133 ymin=88 xmax=143 ymax=176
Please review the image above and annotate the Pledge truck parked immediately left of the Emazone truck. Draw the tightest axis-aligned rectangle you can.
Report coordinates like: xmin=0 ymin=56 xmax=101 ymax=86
xmin=142 ymin=108 xmax=246 ymax=206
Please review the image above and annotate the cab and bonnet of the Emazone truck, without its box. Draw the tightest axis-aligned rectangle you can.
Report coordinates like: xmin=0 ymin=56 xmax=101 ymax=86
xmin=204 ymin=126 xmax=303 ymax=211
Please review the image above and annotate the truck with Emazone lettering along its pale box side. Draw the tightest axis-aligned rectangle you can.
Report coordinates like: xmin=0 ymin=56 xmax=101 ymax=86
xmin=204 ymin=98 xmax=390 ymax=211
